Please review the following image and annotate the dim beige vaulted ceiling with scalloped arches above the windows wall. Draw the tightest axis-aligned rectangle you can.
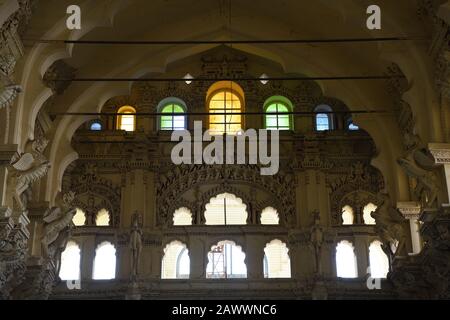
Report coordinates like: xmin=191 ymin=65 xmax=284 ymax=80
xmin=5 ymin=0 xmax=450 ymax=204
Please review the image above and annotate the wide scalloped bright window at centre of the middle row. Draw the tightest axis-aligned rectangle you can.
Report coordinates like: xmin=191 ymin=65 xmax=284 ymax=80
xmin=205 ymin=193 xmax=248 ymax=225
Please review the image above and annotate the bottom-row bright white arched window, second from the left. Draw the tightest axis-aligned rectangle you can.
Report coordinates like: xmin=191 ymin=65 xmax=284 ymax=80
xmin=92 ymin=241 xmax=116 ymax=280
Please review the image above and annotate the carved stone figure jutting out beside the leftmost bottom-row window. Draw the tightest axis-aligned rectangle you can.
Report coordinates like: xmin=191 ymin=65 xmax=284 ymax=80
xmin=41 ymin=192 xmax=76 ymax=259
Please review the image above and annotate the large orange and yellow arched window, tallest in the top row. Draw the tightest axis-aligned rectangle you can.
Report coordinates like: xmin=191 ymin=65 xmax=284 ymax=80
xmin=208 ymin=81 xmax=244 ymax=135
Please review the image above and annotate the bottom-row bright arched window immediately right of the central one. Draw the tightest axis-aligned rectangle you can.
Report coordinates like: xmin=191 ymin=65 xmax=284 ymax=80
xmin=264 ymin=240 xmax=291 ymax=278
